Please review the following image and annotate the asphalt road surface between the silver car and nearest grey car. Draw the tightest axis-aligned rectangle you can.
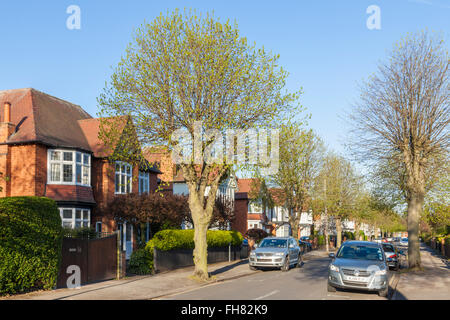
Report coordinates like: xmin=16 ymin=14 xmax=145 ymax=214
xmin=158 ymin=252 xmax=395 ymax=300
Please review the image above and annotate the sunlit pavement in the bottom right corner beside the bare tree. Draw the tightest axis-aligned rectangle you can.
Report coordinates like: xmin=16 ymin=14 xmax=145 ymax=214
xmin=392 ymin=243 xmax=450 ymax=300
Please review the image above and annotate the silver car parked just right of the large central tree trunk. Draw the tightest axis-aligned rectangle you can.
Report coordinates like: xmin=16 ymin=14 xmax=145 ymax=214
xmin=249 ymin=237 xmax=302 ymax=271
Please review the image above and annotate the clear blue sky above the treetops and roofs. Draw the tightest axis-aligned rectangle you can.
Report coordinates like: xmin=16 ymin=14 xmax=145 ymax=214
xmin=0 ymin=0 xmax=450 ymax=158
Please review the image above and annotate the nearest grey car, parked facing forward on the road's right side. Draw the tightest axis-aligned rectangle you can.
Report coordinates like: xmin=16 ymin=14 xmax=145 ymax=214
xmin=328 ymin=241 xmax=389 ymax=297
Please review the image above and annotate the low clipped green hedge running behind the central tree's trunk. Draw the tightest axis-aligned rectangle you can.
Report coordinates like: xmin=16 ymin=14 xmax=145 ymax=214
xmin=152 ymin=229 xmax=244 ymax=251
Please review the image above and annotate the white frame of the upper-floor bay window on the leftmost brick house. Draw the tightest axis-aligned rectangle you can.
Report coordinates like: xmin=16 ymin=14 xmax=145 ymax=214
xmin=47 ymin=149 xmax=92 ymax=187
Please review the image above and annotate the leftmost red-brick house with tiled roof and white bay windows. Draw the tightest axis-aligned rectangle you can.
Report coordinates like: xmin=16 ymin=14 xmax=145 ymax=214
xmin=0 ymin=89 xmax=161 ymax=257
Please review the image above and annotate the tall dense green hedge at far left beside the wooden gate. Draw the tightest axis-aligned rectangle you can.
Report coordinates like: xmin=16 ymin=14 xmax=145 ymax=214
xmin=0 ymin=197 xmax=62 ymax=295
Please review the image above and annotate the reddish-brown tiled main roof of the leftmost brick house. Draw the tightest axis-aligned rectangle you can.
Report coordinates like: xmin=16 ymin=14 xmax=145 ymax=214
xmin=0 ymin=88 xmax=92 ymax=151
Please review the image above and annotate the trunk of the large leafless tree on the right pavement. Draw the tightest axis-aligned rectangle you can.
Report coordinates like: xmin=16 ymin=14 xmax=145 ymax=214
xmin=408 ymin=193 xmax=424 ymax=269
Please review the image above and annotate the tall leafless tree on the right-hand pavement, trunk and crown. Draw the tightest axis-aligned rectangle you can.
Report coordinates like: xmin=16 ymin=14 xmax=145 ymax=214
xmin=350 ymin=32 xmax=450 ymax=269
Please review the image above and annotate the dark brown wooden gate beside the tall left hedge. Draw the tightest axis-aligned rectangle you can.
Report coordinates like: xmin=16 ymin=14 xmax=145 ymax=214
xmin=57 ymin=234 xmax=118 ymax=288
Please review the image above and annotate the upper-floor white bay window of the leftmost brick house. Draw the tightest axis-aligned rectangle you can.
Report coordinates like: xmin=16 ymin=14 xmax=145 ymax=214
xmin=47 ymin=149 xmax=91 ymax=186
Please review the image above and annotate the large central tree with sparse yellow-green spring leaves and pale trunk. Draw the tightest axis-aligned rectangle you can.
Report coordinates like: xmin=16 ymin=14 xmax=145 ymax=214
xmin=98 ymin=11 xmax=300 ymax=280
